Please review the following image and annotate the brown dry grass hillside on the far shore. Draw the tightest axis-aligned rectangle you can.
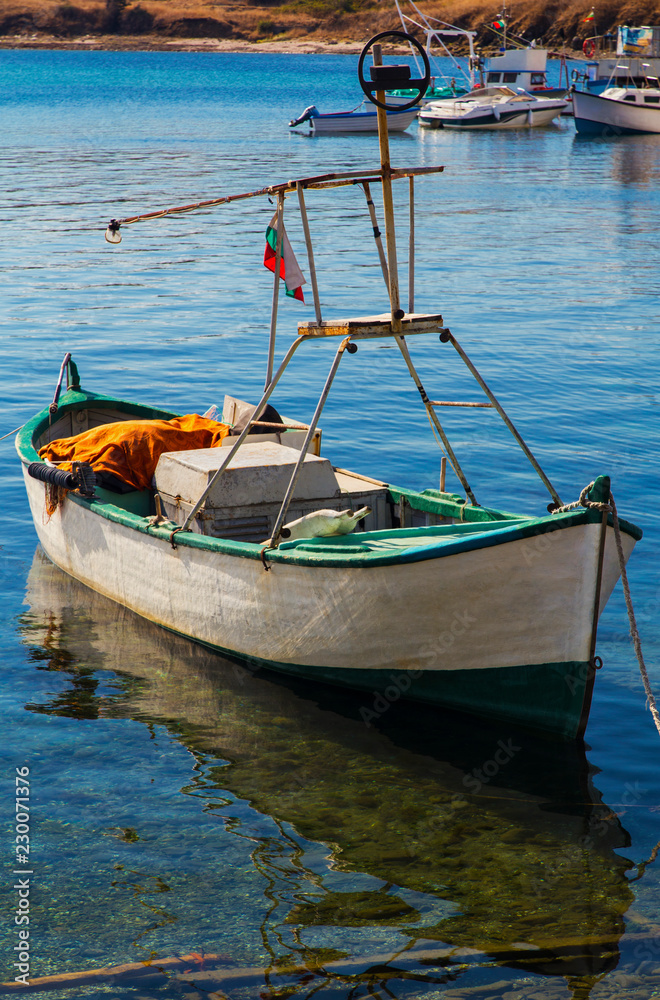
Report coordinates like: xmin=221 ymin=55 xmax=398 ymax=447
xmin=0 ymin=0 xmax=660 ymax=51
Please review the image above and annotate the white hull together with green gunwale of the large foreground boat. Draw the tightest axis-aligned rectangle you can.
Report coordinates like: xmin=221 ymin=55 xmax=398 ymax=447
xmin=18 ymin=386 xmax=640 ymax=736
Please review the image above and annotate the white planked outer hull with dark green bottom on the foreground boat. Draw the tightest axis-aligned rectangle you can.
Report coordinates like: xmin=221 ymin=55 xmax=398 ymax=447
xmin=24 ymin=467 xmax=634 ymax=737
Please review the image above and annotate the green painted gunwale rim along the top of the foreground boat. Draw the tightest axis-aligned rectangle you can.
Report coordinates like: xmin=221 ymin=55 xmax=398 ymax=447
xmin=16 ymin=389 xmax=643 ymax=568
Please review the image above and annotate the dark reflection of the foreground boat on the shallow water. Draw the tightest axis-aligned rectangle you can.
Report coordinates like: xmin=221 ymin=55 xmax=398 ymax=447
xmin=21 ymin=550 xmax=632 ymax=997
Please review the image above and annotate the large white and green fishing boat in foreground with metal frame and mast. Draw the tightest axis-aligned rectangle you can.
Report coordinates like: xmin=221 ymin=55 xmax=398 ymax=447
xmin=17 ymin=36 xmax=641 ymax=737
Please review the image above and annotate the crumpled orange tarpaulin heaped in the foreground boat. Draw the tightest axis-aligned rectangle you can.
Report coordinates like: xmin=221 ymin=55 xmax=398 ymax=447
xmin=39 ymin=413 xmax=229 ymax=490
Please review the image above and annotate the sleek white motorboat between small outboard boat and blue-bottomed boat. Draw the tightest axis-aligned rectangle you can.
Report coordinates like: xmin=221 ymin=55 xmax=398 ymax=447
xmin=419 ymin=86 xmax=568 ymax=130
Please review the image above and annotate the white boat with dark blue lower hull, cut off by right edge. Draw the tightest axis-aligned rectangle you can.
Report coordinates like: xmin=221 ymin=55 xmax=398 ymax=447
xmin=573 ymin=86 xmax=660 ymax=136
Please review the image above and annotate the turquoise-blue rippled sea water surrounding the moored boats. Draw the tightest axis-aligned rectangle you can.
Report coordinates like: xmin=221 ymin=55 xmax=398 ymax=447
xmin=0 ymin=51 xmax=660 ymax=1000
